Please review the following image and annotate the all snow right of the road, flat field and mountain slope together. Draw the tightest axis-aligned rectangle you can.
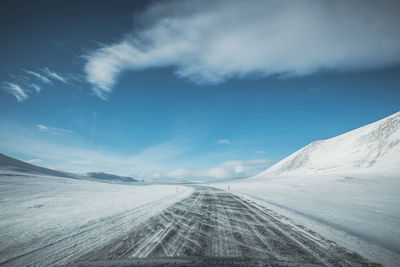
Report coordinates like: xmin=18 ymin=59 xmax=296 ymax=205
xmin=214 ymin=112 xmax=400 ymax=266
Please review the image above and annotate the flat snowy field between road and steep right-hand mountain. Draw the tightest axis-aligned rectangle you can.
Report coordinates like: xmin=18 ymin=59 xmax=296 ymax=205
xmin=214 ymin=175 xmax=400 ymax=266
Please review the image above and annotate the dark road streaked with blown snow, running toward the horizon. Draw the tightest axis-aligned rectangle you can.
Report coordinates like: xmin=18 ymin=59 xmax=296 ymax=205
xmin=73 ymin=186 xmax=373 ymax=266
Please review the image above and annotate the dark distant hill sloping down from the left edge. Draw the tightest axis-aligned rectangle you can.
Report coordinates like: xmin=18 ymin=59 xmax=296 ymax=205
xmin=0 ymin=153 xmax=77 ymax=178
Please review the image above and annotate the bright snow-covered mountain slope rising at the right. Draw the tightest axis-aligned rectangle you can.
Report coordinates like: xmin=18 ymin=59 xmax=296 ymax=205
xmin=255 ymin=112 xmax=400 ymax=177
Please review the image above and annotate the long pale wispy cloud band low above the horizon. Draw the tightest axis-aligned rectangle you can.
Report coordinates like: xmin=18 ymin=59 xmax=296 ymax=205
xmin=0 ymin=123 xmax=271 ymax=179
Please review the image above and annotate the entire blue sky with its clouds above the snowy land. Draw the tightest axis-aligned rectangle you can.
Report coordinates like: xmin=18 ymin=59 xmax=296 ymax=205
xmin=0 ymin=1 xmax=400 ymax=179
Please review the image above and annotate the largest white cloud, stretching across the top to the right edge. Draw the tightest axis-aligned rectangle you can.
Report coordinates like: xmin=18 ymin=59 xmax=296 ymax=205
xmin=85 ymin=0 xmax=400 ymax=98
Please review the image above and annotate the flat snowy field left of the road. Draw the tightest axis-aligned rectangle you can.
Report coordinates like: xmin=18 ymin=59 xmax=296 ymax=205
xmin=0 ymin=174 xmax=192 ymax=265
